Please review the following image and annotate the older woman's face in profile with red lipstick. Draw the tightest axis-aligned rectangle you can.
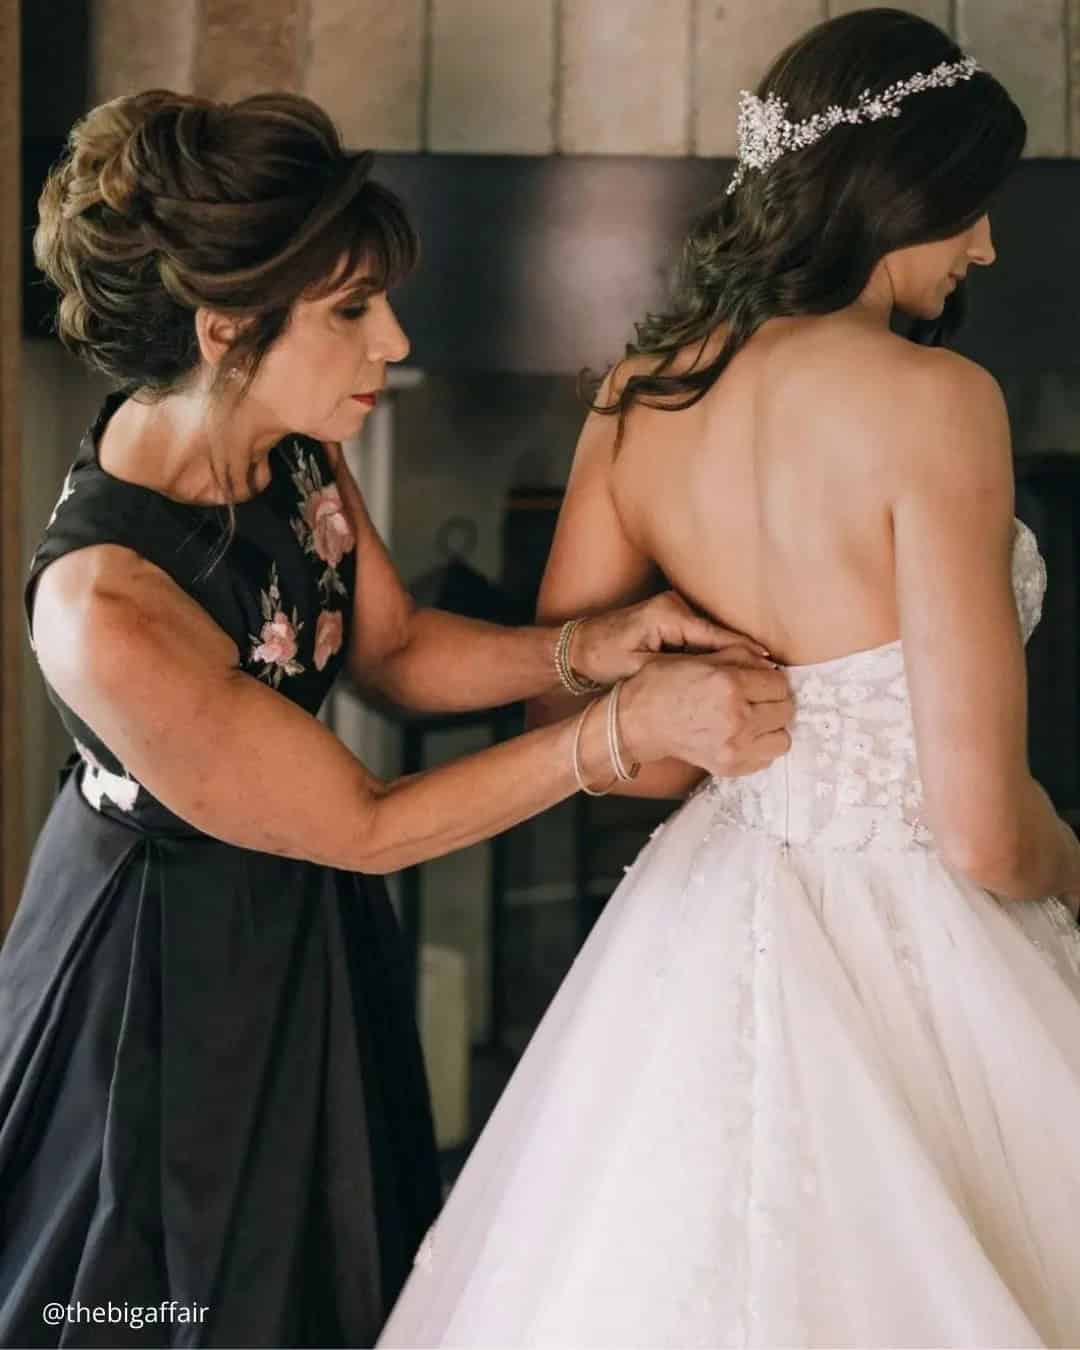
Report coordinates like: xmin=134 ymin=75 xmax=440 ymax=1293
xmin=246 ymin=274 xmax=409 ymax=440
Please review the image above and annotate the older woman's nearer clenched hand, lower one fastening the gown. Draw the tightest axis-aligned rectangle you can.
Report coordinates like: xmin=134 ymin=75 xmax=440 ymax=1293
xmin=618 ymin=652 xmax=795 ymax=778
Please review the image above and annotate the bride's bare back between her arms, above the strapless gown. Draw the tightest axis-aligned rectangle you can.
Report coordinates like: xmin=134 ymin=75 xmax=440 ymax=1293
xmin=609 ymin=312 xmax=956 ymax=675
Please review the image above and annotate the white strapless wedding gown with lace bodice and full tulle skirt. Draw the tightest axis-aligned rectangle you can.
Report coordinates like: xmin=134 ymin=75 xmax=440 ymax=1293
xmin=379 ymin=525 xmax=1080 ymax=1350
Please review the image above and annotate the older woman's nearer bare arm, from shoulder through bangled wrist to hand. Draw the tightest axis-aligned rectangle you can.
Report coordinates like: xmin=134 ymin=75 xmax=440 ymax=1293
xmin=34 ymin=545 xmax=775 ymax=872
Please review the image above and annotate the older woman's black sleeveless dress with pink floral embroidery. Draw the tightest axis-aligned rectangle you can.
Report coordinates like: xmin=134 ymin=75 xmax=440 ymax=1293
xmin=0 ymin=397 xmax=439 ymax=1346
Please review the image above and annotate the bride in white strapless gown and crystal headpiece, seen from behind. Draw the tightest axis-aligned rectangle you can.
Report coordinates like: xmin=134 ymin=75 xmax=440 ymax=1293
xmin=379 ymin=9 xmax=1080 ymax=1347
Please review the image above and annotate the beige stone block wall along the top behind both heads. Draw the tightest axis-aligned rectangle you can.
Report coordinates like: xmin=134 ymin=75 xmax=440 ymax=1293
xmin=90 ymin=0 xmax=1080 ymax=157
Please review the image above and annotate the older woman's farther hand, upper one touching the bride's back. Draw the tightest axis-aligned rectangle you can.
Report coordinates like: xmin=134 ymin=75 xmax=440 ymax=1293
xmin=567 ymin=591 xmax=772 ymax=684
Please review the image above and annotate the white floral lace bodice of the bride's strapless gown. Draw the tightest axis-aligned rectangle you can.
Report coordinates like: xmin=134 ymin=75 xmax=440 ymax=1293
xmin=705 ymin=520 xmax=1046 ymax=851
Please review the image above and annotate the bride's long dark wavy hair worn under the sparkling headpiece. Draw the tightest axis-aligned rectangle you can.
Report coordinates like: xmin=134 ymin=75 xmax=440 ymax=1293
xmin=593 ymin=9 xmax=1027 ymax=433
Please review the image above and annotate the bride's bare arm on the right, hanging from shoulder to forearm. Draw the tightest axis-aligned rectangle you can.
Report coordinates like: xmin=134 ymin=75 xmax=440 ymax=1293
xmin=891 ymin=351 xmax=1080 ymax=899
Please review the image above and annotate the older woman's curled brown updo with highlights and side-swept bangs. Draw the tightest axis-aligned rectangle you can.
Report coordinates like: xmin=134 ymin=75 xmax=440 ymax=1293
xmin=34 ymin=89 xmax=417 ymax=396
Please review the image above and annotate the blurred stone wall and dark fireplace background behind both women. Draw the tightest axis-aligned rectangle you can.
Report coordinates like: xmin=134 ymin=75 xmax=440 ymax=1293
xmin=0 ymin=0 xmax=1080 ymax=1175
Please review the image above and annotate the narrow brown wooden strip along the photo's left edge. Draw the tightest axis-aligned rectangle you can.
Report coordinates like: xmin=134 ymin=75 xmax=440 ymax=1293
xmin=0 ymin=0 xmax=26 ymax=936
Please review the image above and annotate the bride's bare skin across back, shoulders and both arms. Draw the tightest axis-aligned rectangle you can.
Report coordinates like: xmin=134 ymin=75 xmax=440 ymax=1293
xmin=540 ymin=305 xmax=1080 ymax=896
